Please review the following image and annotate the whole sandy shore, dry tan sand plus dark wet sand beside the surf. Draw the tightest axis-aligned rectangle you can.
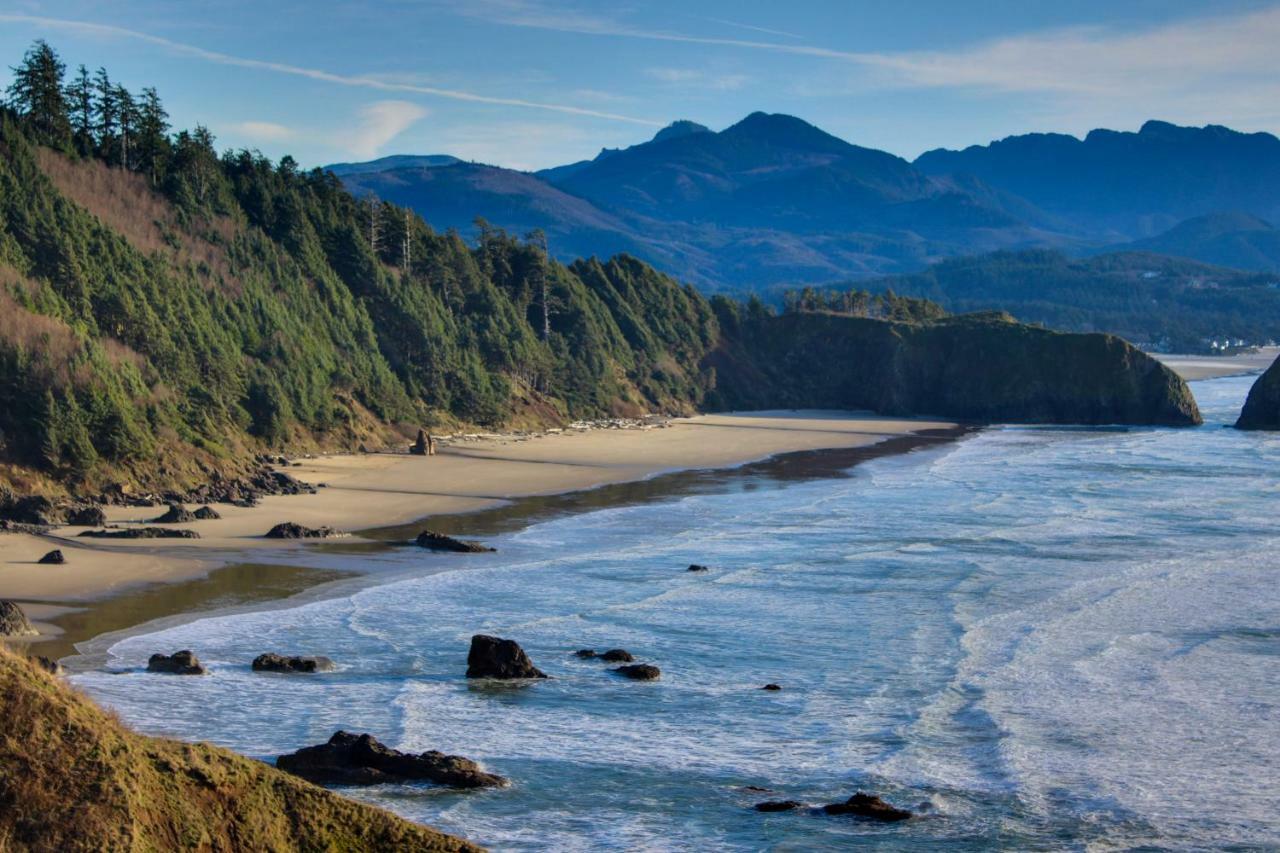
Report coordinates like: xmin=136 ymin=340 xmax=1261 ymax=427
xmin=0 ymin=411 xmax=973 ymax=669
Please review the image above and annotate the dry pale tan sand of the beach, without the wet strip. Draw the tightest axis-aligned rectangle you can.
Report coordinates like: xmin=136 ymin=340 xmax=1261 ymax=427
xmin=0 ymin=411 xmax=954 ymax=650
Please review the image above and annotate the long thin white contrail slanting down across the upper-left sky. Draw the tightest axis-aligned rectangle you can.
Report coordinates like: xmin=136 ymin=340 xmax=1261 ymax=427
xmin=0 ymin=13 xmax=663 ymax=127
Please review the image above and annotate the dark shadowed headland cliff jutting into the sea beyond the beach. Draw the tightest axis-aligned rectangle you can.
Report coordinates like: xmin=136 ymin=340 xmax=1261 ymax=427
xmin=709 ymin=308 xmax=1201 ymax=427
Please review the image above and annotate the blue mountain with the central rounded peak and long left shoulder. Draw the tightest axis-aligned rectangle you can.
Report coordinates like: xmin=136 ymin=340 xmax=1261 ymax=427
xmin=332 ymin=113 xmax=1059 ymax=291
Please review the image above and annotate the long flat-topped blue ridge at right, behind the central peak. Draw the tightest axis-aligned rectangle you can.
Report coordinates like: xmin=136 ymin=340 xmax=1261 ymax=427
xmin=915 ymin=122 xmax=1280 ymax=242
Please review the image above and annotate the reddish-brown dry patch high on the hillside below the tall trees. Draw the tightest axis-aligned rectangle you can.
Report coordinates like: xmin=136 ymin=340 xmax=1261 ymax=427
xmin=37 ymin=147 xmax=243 ymax=295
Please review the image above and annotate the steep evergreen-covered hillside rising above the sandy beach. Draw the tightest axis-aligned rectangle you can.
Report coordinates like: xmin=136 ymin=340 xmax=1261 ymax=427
xmin=0 ymin=42 xmax=1198 ymax=491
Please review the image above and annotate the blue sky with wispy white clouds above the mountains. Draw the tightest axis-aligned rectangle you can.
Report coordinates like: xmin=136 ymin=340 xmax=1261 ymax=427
xmin=0 ymin=0 xmax=1280 ymax=169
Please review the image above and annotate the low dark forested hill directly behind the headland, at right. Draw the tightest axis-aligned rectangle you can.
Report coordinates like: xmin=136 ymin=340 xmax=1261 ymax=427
xmin=861 ymin=250 xmax=1280 ymax=352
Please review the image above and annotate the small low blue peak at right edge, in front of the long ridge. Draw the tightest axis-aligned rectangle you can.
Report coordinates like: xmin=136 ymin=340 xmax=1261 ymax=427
xmin=1110 ymin=213 xmax=1280 ymax=272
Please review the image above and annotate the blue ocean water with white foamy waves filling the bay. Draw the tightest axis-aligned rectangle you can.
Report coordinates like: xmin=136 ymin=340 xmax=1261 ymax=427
xmin=73 ymin=377 xmax=1280 ymax=850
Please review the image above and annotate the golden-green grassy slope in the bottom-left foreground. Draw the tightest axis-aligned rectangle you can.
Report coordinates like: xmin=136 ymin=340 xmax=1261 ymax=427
xmin=0 ymin=648 xmax=479 ymax=850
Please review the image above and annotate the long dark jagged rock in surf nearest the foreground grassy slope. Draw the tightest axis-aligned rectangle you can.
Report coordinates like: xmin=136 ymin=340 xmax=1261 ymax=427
xmin=275 ymin=731 xmax=507 ymax=788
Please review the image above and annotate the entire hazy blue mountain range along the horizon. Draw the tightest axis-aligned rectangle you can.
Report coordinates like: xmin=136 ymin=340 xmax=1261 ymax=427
xmin=333 ymin=113 xmax=1280 ymax=291
